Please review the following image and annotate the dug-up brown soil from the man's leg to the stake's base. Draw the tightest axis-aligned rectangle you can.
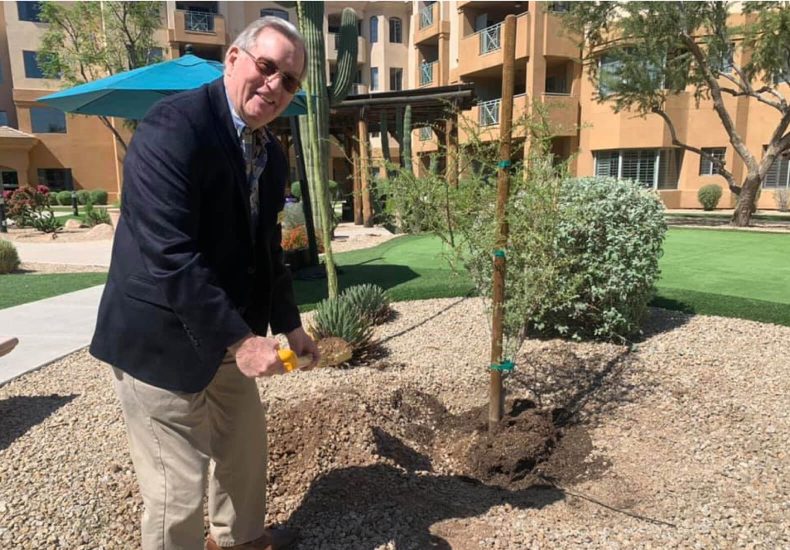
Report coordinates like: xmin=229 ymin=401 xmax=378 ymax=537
xmin=268 ymin=388 xmax=601 ymax=523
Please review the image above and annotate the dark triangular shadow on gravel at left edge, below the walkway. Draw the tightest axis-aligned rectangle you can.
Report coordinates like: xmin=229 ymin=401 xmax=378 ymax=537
xmin=0 ymin=395 xmax=77 ymax=451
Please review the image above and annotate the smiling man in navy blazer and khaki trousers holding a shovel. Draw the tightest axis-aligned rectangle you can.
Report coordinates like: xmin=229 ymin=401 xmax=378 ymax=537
xmin=91 ymin=17 xmax=319 ymax=550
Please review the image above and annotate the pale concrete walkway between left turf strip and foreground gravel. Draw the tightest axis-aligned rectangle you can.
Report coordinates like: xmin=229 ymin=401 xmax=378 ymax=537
xmin=0 ymin=285 xmax=104 ymax=385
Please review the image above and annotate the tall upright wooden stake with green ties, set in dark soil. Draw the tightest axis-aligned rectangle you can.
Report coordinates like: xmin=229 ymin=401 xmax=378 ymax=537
xmin=488 ymin=15 xmax=516 ymax=431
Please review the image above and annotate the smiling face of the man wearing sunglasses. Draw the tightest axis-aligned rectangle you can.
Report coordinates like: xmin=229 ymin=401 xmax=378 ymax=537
xmin=225 ymin=28 xmax=304 ymax=129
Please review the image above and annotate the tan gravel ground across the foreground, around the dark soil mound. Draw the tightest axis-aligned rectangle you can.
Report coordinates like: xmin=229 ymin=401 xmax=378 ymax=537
xmin=0 ymin=299 xmax=790 ymax=550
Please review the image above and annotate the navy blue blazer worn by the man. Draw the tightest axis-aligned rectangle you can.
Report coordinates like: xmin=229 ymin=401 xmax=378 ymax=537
xmin=90 ymin=78 xmax=301 ymax=392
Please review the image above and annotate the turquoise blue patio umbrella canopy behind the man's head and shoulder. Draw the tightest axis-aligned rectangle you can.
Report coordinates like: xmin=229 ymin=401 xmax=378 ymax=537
xmin=38 ymin=54 xmax=307 ymax=120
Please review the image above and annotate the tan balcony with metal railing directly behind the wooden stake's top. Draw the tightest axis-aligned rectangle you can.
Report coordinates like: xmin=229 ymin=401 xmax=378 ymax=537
xmin=458 ymin=13 xmax=530 ymax=78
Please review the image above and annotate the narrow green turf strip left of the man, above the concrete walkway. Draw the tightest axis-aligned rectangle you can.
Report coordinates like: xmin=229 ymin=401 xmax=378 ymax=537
xmin=0 ymin=273 xmax=107 ymax=309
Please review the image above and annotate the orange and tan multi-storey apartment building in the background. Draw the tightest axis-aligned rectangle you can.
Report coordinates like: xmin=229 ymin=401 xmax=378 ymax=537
xmin=0 ymin=0 xmax=790 ymax=209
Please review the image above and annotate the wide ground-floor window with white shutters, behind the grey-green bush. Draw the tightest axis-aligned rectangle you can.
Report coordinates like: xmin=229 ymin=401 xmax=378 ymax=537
xmin=593 ymin=149 xmax=683 ymax=189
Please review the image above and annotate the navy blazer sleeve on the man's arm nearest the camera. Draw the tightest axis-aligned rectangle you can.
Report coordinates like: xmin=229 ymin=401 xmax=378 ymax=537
xmin=122 ymin=99 xmax=250 ymax=357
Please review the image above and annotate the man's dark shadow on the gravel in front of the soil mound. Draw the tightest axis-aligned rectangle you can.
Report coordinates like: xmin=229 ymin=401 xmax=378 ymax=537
xmin=288 ymin=428 xmax=564 ymax=550
